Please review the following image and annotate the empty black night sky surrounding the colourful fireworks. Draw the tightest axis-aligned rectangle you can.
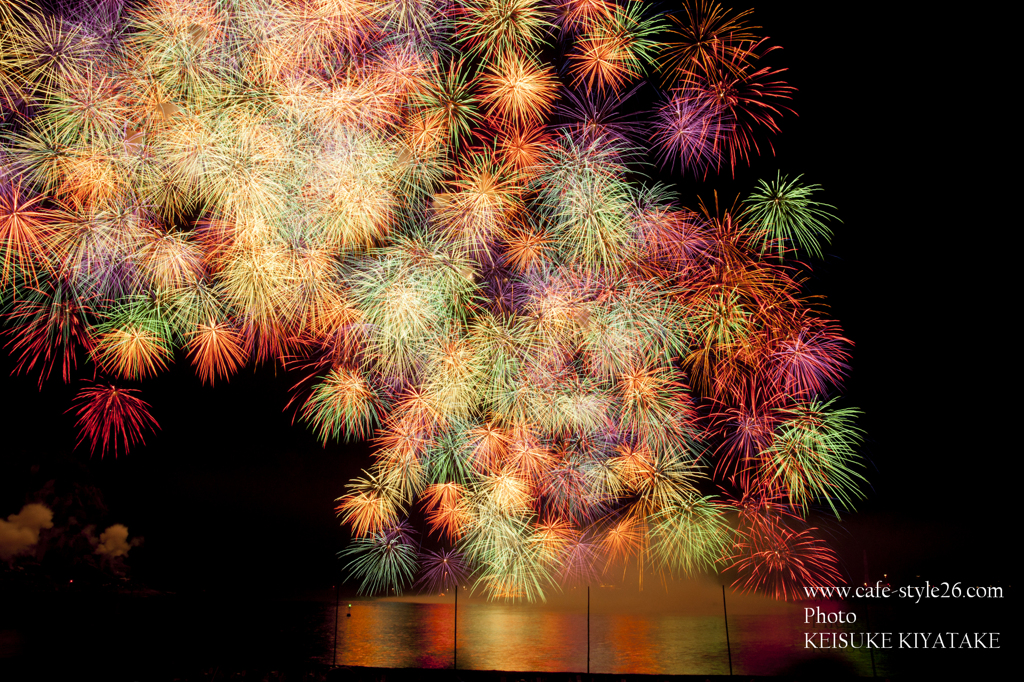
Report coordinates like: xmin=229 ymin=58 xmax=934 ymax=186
xmin=0 ymin=3 xmax=1016 ymax=602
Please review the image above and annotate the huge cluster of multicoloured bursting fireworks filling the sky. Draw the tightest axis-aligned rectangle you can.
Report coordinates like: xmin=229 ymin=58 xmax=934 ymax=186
xmin=0 ymin=0 xmax=860 ymax=600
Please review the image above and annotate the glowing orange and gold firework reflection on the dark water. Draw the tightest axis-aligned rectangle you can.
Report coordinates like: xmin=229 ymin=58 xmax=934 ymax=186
xmin=331 ymin=600 xmax=881 ymax=676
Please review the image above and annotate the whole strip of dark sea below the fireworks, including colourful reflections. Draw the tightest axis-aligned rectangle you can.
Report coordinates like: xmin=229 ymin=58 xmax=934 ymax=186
xmin=0 ymin=586 xmax=1010 ymax=680
